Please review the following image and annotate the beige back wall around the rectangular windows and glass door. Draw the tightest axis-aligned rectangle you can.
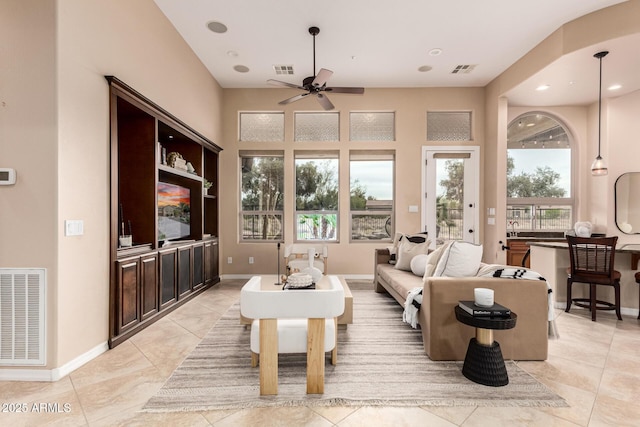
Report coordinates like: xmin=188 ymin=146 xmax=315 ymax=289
xmin=221 ymin=88 xmax=485 ymax=276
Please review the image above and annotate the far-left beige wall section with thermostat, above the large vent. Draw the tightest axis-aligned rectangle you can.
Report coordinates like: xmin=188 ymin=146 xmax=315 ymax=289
xmin=0 ymin=0 xmax=58 ymax=372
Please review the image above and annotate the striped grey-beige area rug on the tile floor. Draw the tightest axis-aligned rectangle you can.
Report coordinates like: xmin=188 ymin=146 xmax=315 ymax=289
xmin=143 ymin=290 xmax=567 ymax=412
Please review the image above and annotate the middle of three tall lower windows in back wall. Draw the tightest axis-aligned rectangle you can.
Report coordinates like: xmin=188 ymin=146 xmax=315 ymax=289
xmin=295 ymin=151 xmax=338 ymax=242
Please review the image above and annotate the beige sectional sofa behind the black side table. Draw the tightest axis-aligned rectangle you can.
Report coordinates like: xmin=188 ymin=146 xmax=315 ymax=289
xmin=374 ymin=249 xmax=548 ymax=360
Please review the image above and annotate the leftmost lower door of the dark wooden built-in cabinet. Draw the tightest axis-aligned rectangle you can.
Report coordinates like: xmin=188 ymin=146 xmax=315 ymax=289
xmin=116 ymin=258 xmax=140 ymax=334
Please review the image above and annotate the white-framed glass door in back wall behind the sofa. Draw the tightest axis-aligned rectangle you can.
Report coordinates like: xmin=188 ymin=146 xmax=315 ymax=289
xmin=422 ymin=147 xmax=480 ymax=247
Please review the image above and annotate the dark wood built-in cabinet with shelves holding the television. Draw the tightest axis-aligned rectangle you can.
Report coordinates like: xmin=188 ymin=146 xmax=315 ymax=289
xmin=107 ymin=76 xmax=221 ymax=347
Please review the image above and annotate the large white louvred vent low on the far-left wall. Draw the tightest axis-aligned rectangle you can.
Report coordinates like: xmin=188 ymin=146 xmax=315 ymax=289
xmin=0 ymin=268 xmax=46 ymax=366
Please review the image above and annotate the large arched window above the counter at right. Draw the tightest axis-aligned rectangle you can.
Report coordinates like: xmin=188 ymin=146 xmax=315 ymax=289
xmin=507 ymin=113 xmax=574 ymax=232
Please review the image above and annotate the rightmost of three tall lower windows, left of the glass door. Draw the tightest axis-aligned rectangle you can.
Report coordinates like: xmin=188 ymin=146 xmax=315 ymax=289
xmin=349 ymin=151 xmax=395 ymax=241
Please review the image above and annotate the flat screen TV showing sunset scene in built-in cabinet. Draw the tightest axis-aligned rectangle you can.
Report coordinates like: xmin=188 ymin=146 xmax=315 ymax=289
xmin=158 ymin=182 xmax=191 ymax=241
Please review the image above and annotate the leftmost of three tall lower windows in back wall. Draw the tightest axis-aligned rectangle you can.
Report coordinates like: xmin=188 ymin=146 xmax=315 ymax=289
xmin=240 ymin=151 xmax=284 ymax=242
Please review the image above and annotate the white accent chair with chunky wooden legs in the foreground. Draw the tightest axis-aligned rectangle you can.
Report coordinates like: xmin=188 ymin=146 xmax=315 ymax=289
xmin=240 ymin=276 xmax=344 ymax=395
